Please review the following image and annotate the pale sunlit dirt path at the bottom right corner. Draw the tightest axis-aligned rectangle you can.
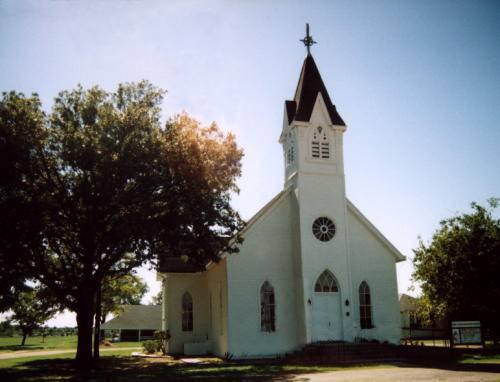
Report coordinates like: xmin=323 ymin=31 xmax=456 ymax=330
xmin=292 ymin=367 xmax=500 ymax=382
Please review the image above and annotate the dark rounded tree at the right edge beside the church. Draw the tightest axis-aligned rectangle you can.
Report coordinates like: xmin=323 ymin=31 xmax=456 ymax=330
xmin=413 ymin=199 xmax=500 ymax=338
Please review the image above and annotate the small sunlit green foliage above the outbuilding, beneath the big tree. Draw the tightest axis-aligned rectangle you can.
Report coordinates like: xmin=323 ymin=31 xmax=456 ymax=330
xmin=101 ymin=272 xmax=149 ymax=322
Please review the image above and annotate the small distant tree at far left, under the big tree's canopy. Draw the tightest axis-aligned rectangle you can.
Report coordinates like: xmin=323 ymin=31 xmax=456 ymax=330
xmin=10 ymin=287 xmax=58 ymax=346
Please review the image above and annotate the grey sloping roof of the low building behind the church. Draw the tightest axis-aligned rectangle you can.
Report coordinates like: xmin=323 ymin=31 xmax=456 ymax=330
xmin=101 ymin=305 xmax=161 ymax=330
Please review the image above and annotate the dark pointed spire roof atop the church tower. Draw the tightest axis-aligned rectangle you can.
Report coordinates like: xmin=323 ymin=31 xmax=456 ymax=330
xmin=285 ymin=54 xmax=345 ymax=126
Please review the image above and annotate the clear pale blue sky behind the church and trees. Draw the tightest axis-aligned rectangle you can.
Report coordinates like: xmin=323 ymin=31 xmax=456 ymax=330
xmin=0 ymin=0 xmax=500 ymax=325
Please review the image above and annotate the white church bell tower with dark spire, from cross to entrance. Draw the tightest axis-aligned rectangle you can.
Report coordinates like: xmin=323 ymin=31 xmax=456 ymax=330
xmin=280 ymin=26 xmax=353 ymax=343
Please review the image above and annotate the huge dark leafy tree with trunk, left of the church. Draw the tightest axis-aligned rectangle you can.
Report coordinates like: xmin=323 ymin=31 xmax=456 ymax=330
xmin=0 ymin=82 xmax=242 ymax=366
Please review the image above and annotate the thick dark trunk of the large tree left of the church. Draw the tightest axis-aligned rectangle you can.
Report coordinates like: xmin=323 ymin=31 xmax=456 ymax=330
xmin=76 ymin=291 xmax=94 ymax=369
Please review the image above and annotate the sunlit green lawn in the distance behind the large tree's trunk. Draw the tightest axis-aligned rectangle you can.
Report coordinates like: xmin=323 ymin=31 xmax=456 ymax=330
xmin=0 ymin=336 xmax=142 ymax=353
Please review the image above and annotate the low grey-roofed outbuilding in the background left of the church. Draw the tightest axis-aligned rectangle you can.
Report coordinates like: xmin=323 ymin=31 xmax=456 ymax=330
xmin=101 ymin=305 xmax=161 ymax=341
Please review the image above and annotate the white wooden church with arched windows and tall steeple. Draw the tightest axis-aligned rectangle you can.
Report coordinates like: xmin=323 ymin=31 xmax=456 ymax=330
xmin=158 ymin=36 xmax=405 ymax=358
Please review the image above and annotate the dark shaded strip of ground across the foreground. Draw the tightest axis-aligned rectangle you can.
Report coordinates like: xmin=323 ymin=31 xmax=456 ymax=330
xmin=0 ymin=356 xmax=500 ymax=382
